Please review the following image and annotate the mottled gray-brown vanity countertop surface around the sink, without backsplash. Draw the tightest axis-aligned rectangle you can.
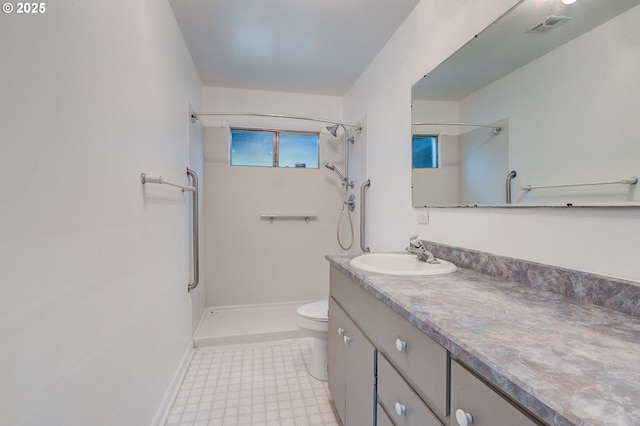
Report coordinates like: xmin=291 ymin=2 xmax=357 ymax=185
xmin=326 ymin=255 xmax=640 ymax=426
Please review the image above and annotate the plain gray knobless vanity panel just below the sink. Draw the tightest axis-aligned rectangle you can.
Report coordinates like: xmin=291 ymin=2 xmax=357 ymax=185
xmin=329 ymin=266 xmax=378 ymax=340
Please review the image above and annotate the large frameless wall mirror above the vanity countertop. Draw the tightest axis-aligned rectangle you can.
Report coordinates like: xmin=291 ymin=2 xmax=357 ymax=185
xmin=412 ymin=0 xmax=640 ymax=207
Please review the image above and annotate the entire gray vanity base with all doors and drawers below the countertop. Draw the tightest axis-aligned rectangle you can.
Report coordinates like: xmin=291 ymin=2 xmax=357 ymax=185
xmin=329 ymin=266 xmax=543 ymax=426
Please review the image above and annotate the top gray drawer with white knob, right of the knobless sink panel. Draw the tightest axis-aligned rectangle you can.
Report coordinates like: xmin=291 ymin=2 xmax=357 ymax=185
xmin=377 ymin=302 xmax=447 ymax=420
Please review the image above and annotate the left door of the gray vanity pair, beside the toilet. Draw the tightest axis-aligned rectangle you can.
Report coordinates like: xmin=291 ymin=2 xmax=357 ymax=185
xmin=327 ymin=297 xmax=350 ymax=424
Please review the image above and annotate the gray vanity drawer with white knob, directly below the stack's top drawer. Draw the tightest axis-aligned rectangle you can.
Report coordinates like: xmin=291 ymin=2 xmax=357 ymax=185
xmin=378 ymin=355 xmax=442 ymax=426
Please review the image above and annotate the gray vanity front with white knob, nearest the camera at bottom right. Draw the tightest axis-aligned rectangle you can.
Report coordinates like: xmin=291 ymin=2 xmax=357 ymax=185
xmin=451 ymin=361 xmax=542 ymax=426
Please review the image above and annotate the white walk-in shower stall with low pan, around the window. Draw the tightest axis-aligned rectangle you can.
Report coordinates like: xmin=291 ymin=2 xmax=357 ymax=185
xmin=192 ymin=113 xmax=360 ymax=346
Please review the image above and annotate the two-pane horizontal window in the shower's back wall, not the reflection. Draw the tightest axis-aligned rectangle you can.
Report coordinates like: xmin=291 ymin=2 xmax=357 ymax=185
xmin=231 ymin=129 xmax=319 ymax=169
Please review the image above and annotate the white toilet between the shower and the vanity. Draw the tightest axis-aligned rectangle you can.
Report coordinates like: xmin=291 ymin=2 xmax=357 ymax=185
xmin=296 ymin=300 xmax=329 ymax=380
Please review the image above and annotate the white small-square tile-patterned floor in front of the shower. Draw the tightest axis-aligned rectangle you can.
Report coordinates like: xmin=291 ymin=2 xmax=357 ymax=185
xmin=166 ymin=338 xmax=338 ymax=426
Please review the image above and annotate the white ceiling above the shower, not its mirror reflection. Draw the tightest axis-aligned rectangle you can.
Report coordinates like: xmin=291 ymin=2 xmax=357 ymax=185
xmin=169 ymin=0 xmax=419 ymax=96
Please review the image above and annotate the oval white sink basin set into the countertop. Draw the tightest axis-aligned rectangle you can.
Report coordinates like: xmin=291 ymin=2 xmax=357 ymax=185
xmin=349 ymin=253 xmax=458 ymax=275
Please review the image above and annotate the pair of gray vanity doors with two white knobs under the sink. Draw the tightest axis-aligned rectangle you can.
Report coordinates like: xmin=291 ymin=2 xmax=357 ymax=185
xmin=328 ymin=297 xmax=376 ymax=426
